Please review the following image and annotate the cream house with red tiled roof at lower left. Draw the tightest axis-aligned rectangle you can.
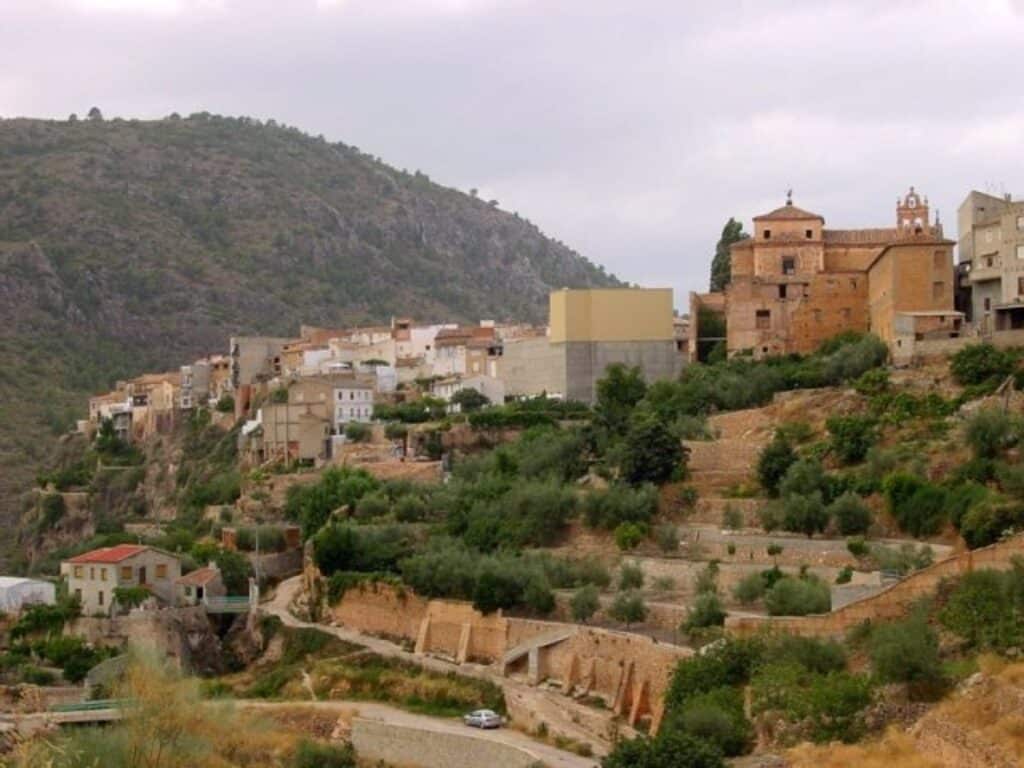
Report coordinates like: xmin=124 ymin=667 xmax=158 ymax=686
xmin=60 ymin=544 xmax=181 ymax=615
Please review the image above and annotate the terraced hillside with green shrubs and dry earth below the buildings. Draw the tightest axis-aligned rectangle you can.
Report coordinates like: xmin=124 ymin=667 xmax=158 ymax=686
xmin=16 ymin=335 xmax=1024 ymax=768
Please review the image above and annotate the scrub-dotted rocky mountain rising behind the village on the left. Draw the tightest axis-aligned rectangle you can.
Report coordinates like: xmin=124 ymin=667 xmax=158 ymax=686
xmin=0 ymin=114 xmax=618 ymax=548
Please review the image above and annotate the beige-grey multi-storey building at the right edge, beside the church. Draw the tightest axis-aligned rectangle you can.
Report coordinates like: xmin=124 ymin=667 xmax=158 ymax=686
xmin=956 ymin=190 xmax=1024 ymax=333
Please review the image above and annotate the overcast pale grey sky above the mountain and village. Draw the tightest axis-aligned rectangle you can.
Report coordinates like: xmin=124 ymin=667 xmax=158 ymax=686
xmin=0 ymin=0 xmax=1024 ymax=306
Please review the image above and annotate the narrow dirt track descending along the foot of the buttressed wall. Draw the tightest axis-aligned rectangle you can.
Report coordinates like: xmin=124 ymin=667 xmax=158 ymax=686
xmin=260 ymin=575 xmax=606 ymax=766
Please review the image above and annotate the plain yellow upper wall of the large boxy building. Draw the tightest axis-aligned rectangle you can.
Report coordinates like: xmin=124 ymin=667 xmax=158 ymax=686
xmin=549 ymin=288 xmax=675 ymax=344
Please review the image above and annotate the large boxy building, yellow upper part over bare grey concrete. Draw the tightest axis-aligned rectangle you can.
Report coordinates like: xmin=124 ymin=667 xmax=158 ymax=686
xmin=495 ymin=288 xmax=680 ymax=402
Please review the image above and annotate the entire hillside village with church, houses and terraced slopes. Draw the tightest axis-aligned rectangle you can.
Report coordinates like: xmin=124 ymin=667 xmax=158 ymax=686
xmin=6 ymin=187 xmax=1024 ymax=768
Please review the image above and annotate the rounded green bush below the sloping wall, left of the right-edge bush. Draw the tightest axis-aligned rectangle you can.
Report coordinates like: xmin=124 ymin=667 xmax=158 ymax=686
xmin=868 ymin=617 xmax=942 ymax=683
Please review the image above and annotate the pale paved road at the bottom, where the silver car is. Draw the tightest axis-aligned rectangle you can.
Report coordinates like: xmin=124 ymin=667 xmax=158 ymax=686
xmin=236 ymin=699 xmax=597 ymax=768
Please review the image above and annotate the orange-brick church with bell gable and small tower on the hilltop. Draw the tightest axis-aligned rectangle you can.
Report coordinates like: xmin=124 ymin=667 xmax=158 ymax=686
xmin=687 ymin=187 xmax=963 ymax=359
